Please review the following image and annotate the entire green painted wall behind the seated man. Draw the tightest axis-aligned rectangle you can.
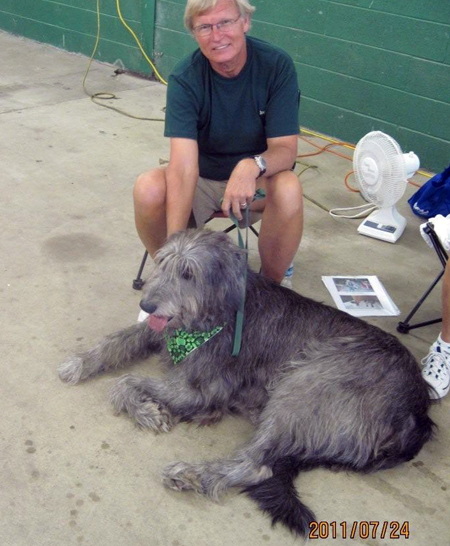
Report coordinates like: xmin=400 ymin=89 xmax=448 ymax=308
xmin=0 ymin=0 xmax=450 ymax=171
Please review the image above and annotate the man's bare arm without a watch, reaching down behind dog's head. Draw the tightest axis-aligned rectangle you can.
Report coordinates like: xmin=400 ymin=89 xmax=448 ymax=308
xmin=166 ymin=138 xmax=198 ymax=236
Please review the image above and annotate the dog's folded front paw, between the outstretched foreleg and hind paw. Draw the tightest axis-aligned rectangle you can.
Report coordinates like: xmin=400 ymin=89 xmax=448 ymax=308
xmin=111 ymin=375 xmax=173 ymax=432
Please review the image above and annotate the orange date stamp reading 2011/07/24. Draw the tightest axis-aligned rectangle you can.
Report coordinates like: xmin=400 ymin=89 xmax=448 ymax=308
xmin=309 ymin=520 xmax=410 ymax=540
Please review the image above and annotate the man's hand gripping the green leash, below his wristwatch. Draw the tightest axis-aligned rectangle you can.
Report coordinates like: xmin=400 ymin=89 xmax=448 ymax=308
xmin=222 ymin=157 xmax=259 ymax=220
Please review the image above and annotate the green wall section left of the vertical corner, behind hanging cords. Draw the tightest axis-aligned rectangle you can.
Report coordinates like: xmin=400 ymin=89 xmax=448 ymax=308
xmin=0 ymin=0 xmax=156 ymax=73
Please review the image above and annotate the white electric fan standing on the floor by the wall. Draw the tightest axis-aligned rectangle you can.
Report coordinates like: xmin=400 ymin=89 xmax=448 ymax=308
xmin=353 ymin=131 xmax=420 ymax=243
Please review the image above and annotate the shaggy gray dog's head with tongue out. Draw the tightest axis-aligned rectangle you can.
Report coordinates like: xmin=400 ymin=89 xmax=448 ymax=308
xmin=141 ymin=229 xmax=247 ymax=331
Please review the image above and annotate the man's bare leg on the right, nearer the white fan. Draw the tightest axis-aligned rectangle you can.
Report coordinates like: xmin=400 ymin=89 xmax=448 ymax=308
xmin=252 ymin=171 xmax=303 ymax=283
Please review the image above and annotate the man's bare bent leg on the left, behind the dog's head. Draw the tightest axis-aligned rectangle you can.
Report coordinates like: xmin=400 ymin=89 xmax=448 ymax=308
xmin=133 ymin=168 xmax=167 ymax=257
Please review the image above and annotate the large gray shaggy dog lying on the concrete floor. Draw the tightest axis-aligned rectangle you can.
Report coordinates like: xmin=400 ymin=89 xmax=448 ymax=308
xmin=59 ymin=230 xmax=434 ymax=535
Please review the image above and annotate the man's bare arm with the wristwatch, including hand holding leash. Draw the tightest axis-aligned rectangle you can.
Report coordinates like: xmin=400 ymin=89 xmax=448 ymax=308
xmin=222 ymin=135 xmax=297 ymax=220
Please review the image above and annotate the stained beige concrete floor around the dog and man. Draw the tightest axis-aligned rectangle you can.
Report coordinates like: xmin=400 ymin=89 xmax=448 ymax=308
xmin=0 ymin=33 xmax=450 ymax=546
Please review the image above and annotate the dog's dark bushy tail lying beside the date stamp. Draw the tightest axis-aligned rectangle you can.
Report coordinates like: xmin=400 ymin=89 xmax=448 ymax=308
xmin=243 ymin=457 xmax=316 ymax=537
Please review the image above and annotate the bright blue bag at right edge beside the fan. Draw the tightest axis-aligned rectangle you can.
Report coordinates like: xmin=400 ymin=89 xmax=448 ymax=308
xmin=408 ymin=165 xmax=450 ymax=219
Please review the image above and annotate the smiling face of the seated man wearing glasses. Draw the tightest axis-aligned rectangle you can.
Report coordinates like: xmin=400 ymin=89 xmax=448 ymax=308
xmin=193 ymin=0 xmax=250 ymax=72
